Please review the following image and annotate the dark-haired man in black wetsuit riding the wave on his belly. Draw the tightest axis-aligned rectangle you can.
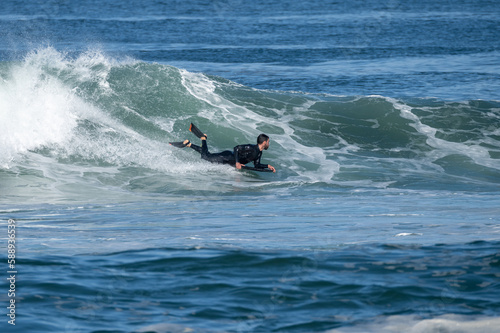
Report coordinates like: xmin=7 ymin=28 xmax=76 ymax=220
xmin=179 ymin=134 xmax=276 ymax=172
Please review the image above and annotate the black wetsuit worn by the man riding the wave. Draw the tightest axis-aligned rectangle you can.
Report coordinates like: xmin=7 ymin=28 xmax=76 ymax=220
xmin=191 ymin=140 xmax=267 ymax=169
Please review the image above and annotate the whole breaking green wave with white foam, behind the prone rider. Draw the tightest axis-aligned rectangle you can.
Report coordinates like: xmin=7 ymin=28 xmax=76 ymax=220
xmin=0 ymin=47 xmax=500 ymax=201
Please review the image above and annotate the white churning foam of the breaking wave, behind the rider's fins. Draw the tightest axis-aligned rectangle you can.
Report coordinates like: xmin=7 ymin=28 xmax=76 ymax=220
xmin=0 ymin=47 xmax=161 ymax=168
